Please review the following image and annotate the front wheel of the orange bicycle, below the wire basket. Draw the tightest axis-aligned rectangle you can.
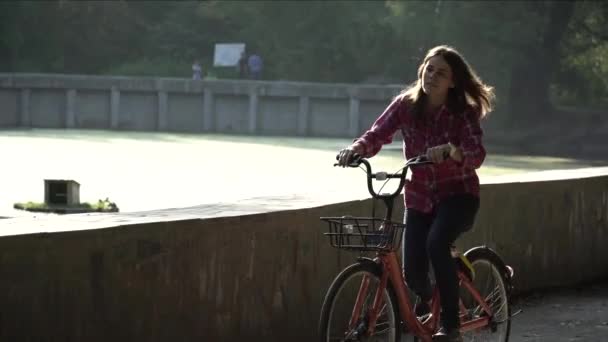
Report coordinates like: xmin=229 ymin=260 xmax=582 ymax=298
xmin=319 ymin=262 xmax=401 ymax=342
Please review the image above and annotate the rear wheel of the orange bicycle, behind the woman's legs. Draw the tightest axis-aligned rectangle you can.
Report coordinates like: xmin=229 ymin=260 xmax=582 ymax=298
xmin=460 ymin=248 xmax=511 ymax=342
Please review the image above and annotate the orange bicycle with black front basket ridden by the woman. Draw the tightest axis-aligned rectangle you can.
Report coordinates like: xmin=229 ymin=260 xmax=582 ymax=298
xmin=319 ymin=156 xmax=513 ymax=342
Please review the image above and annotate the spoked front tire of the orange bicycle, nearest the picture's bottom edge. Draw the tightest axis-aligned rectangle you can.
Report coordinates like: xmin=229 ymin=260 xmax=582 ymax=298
xmin=319 ymin=260 xmax=401 ymax=342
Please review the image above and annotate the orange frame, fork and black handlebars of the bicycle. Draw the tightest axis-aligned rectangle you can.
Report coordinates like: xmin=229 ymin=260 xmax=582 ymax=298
xmin=338 ymin=156 xmax=493 ymax=342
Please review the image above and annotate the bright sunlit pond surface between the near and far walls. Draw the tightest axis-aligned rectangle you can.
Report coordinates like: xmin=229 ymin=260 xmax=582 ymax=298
xmin=0 ymin=130 xmax=604 ymax=216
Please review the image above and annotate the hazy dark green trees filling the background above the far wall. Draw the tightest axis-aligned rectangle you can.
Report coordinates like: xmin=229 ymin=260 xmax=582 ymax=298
xmin=0 ymin=0 xmax=608 ymax=118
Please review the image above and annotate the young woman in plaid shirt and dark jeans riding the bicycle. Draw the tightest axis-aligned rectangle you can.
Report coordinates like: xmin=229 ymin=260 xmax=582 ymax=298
xmin=339 ymin=45 xmax=494 ymax=341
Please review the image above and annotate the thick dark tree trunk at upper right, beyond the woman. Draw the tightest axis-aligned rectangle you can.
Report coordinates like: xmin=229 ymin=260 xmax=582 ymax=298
xmin=509 ymin=1 xmax=575 ymax=127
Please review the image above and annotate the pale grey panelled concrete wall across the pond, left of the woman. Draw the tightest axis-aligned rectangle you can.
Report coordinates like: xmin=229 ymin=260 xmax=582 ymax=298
xmin=0 ymin=73 xmax=401 ymax=137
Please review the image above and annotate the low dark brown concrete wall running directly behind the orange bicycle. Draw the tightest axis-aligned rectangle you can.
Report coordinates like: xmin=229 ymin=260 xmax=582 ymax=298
xmin=0 ymin=176 xmax=608 ymax=342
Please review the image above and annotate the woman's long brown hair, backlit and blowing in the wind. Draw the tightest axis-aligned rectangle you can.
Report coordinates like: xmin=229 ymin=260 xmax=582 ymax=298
xmin=397 ymin=45 xmax=495 ymax=118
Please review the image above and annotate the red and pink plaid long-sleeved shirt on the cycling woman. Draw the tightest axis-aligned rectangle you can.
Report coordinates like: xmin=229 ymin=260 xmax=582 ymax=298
xmin=355 ymin=99 xmax=486 ymax=213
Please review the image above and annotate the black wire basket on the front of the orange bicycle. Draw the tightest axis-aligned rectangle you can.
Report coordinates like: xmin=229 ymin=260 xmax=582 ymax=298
xmin=321 ymin=216 xmax=405 ymax=252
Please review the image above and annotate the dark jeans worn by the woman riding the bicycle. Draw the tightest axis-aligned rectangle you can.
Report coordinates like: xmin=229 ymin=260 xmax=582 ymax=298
xmin=402 ymin=194 xmax=479 ymax=329
